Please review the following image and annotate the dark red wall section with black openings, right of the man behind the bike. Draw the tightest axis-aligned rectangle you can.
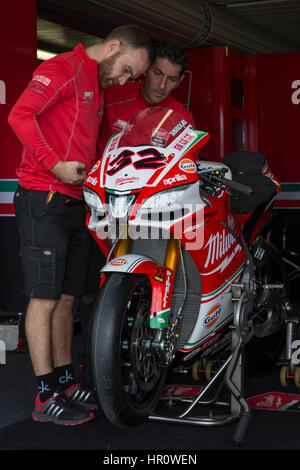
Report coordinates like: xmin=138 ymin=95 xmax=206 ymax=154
xmin=175 ymin=47 xmax=258 ymax=161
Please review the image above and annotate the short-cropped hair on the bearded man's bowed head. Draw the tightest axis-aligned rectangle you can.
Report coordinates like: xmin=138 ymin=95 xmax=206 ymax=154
xmin=104 ymin=24 xmax=153 ymax=62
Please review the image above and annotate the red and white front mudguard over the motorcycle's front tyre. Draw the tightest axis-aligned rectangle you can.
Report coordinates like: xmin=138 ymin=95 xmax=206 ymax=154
xmin=101 ymin=254 xmax=173 ymax=328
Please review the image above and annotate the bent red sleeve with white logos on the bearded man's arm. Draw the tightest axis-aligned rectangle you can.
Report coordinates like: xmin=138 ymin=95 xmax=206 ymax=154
xmin=8 ymin=58 xmax=72 ymax=169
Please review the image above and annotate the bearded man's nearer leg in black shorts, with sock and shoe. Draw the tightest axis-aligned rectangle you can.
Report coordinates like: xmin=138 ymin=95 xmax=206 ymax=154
xmin=15 ymin=188 xmax=94 ymax=425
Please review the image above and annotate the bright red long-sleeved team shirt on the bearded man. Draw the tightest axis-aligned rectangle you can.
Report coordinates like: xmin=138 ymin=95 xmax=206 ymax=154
xmin=9 ymin=44 xmax=103 ymax=202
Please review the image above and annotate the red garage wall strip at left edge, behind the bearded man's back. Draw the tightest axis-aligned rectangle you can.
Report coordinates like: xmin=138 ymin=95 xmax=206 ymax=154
xmin=0 ymin=0 xmax=36 ymax=311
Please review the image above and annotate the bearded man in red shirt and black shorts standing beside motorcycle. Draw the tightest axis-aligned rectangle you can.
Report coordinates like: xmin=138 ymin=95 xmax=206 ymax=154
xmin=9 ymin=25 xmax=152 ymax=425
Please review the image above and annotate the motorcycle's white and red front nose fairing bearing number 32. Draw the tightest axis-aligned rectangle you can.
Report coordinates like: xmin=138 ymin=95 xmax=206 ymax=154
xmin=92 ymin=126 xmax=210 ymax=194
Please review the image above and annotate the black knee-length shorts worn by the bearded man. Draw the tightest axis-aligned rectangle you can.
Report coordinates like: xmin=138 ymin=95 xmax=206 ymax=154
xmin=14 ymin=186 xmax=92 ymax=300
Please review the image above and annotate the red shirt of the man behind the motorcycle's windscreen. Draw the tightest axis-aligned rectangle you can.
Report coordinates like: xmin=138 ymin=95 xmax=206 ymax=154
xmin=98 ymin=82 xmax=195 ymax=157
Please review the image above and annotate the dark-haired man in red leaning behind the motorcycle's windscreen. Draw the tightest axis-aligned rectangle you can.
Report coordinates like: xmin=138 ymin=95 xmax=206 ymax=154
xmin=98 ymin=42 xmax=194 ymax=157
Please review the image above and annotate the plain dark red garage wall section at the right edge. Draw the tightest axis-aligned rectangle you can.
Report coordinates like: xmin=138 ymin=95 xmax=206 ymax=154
xmin=256 ymin=53 xmax=300 ymax=209
